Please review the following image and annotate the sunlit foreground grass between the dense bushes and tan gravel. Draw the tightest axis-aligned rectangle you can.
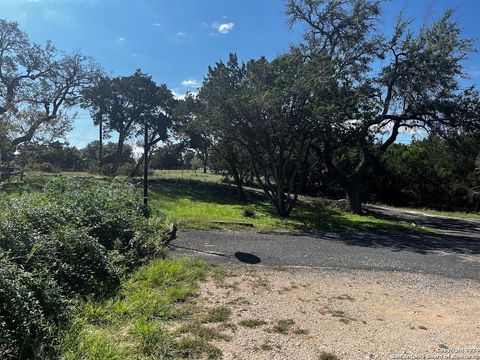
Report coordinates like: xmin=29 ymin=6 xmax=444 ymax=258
xmin=62 ymin=259 xmax=229 ymax=360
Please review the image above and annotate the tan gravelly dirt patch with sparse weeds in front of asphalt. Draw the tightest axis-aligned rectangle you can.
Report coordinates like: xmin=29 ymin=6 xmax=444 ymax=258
xmin=198 ymin=267 xmax=480 ymax=360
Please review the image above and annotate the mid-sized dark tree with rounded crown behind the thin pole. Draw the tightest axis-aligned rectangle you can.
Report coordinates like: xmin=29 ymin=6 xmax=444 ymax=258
xmin=84 ymin=69 xmax=174 ymax=176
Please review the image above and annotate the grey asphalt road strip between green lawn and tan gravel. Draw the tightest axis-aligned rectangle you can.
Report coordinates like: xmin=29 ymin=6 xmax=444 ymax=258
xmin=170 ymin=207 xmax=480 ymax=281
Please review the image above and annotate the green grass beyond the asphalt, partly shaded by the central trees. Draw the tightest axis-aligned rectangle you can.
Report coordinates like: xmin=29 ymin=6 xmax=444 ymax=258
xmin=150 ymin=171 xmax=428 ymax=231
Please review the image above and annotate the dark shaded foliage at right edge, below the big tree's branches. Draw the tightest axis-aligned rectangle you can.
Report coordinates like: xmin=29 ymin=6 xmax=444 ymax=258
xmin=368 ymin=135 xmax=480 ymax=211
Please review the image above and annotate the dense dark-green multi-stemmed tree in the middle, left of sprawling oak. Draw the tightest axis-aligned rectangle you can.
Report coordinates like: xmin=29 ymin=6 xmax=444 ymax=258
xmin=198 ymin=52 xmax=311 ymax=216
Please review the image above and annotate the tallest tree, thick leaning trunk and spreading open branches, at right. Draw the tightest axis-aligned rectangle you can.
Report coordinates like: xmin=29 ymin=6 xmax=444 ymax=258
xmin=287 ymin=0 xmax=479 ymax=213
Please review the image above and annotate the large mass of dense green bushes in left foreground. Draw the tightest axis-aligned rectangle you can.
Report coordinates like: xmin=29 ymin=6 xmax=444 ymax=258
xmin=0 ymin=178 xmax=169 ymax=359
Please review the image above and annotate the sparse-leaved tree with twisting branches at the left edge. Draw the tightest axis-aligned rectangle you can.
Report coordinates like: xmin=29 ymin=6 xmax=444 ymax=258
xmin=0 ymin=19 xmax=99 ymax=160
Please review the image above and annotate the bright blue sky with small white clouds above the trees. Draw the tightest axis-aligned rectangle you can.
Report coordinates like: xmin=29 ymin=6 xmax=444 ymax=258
xmin=0 ymin=0 xmax=480 ymax=147
